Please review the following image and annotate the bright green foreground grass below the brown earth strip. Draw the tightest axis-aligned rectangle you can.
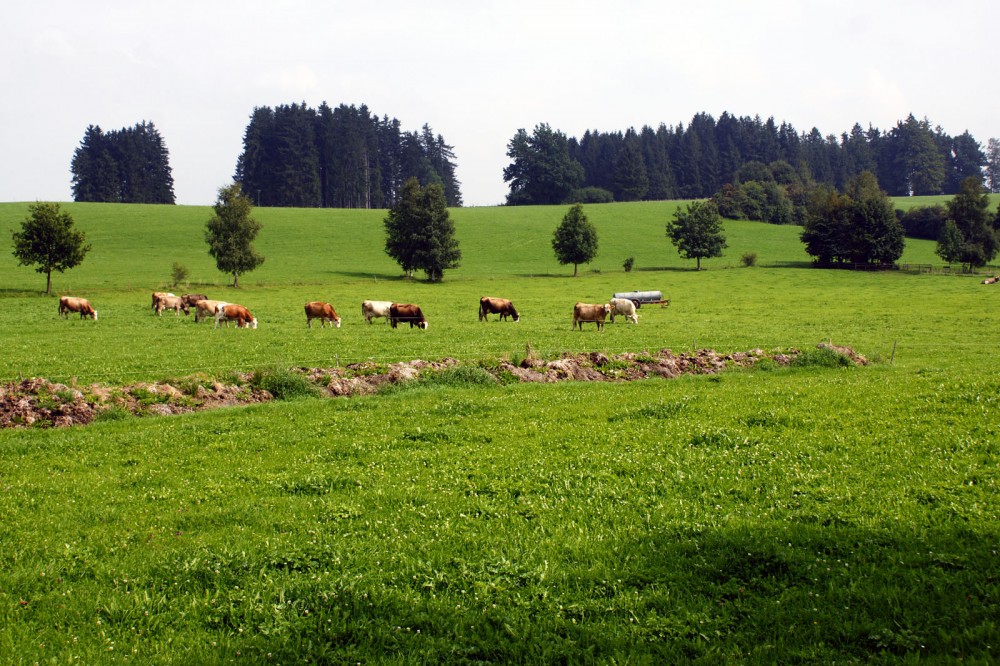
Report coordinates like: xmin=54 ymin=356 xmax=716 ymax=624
xmin=0 ymin=367 xmax=1000 ymax=663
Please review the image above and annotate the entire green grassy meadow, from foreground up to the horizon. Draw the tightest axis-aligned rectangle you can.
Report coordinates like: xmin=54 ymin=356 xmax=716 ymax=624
xmin=0 ymin=200 xmax=1000 ymax=664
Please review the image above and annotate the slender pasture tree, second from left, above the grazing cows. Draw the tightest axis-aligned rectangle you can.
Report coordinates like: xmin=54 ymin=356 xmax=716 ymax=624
xmin=205 ymin=183 xmax=264 ymax=287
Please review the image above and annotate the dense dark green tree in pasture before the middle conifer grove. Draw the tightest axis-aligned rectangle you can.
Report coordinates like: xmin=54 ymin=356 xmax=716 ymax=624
xmin=384 ymin=177 xmax=462 ymax=282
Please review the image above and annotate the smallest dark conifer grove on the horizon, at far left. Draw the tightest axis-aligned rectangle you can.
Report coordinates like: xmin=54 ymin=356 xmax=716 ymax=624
xmin=70 ymin=121 xmax=174 ymax=204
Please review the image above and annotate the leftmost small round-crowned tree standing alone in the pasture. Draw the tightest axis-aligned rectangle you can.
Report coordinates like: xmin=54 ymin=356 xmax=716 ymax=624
xmin=14 ymin=203 xmax=90 ymax=294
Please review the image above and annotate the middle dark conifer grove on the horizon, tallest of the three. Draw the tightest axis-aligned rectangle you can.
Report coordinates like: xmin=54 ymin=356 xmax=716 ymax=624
xmin=235 ymin=102 xmax=462 ymax=208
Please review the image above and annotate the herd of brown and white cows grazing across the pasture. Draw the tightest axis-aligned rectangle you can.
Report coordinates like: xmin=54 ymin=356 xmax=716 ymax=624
xmin=59 ymin=291 xmax=639 ymax=331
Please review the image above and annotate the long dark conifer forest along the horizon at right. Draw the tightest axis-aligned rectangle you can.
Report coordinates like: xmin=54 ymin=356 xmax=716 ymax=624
xmin=503 ymin=112 xmax=1000 ymax=205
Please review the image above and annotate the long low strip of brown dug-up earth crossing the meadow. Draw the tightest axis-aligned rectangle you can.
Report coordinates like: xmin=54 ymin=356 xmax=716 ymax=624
xmin=0 ymin=344 xmax=868 ymax=428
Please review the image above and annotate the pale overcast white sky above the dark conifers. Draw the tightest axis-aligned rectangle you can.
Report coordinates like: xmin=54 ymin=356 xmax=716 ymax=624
xmin=0 ymin=0 xmax=1000 ymax=205
